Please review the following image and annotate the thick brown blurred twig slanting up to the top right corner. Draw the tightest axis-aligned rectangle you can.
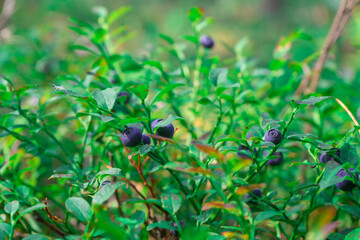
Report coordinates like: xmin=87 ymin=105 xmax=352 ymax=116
xmin=295 ymin=0 xmax=360 ymax=96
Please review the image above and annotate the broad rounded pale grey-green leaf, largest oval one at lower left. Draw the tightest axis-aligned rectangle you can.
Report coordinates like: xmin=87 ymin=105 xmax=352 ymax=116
xmin=65 ymin=197 xmax=91 ymax=222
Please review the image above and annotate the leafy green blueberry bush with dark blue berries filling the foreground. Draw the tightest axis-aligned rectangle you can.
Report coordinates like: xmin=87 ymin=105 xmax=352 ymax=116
xmin=0 ymin=7 xmax=360 ymax=240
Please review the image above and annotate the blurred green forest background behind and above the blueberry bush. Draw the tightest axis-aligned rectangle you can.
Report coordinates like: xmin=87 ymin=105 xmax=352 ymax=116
xmin=0 ymin=0 xmax=360 ymax=84
